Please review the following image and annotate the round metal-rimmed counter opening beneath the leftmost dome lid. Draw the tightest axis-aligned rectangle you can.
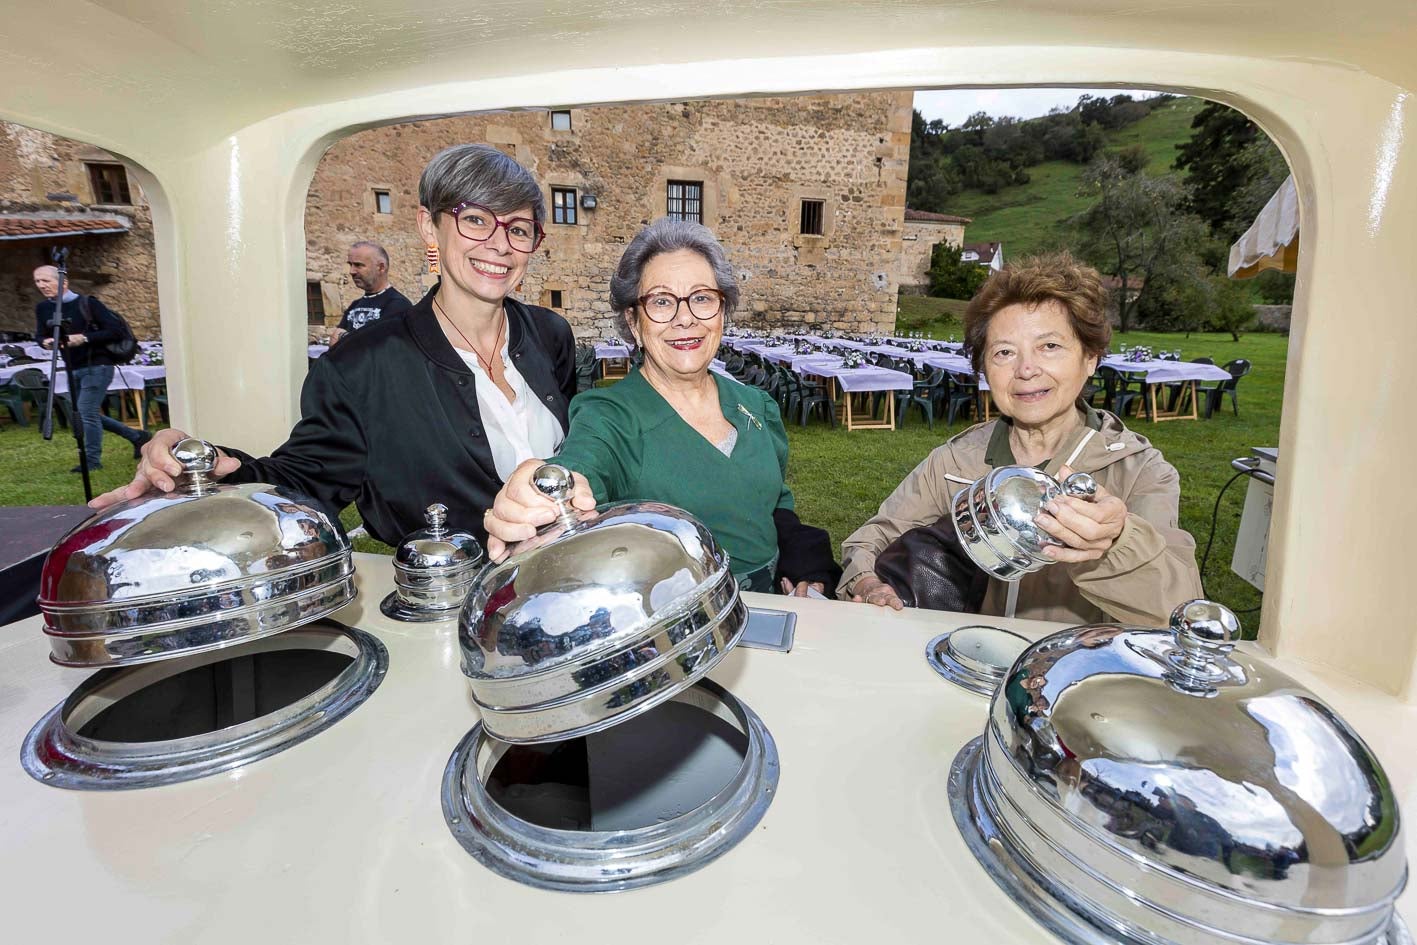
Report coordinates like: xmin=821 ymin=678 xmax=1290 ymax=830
xmin=21 ymin=621 xmax=388 ymax=791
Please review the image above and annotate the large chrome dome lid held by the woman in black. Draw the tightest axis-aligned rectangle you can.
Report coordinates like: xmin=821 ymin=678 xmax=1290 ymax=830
xmin=40 ymin=438 xmax=354 ymax=666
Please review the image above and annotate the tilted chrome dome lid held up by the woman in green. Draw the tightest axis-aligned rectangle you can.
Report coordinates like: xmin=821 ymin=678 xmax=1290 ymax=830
xmin=458 ymin=465 xmax=747 ymax=742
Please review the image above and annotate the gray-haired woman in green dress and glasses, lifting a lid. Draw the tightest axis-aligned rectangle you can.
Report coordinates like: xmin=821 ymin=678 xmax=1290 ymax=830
xmin=486 ymin=218 xmax=840 ymax=595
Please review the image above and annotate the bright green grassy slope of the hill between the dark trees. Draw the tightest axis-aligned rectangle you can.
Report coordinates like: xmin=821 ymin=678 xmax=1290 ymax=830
xmin=949 ymin=98 xmax=1206 ymax=259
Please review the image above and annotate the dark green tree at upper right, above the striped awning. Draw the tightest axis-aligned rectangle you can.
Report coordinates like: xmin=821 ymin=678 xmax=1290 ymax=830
xmin=1175 ymin=102 xmax=1289 ymax=242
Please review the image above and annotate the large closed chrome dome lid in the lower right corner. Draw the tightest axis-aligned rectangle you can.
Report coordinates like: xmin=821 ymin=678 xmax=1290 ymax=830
xmin=951 ymin=601 xmax=1407 ymax=945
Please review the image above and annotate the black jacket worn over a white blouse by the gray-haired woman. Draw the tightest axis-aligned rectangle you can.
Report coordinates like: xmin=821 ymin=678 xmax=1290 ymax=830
xmin=222 ymin=286 xmax=575 ymax=545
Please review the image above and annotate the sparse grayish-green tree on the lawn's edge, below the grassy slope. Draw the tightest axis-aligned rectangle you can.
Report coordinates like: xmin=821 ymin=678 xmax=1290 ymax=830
xmin=1076 ymin=156 xmax=1204 ymax=332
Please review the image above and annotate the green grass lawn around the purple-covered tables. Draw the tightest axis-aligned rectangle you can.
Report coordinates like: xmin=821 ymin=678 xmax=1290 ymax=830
xmin=0 ymin=323 xmax=1288 ymax=632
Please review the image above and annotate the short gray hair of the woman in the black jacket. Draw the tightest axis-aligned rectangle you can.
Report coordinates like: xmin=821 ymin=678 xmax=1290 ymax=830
xmin=418 ymin=145 xmax=546 ymax=222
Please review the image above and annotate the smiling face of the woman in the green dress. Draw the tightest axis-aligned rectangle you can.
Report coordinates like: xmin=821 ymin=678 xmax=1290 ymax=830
xmin=629 ymin=249 xmax=724 ymax=378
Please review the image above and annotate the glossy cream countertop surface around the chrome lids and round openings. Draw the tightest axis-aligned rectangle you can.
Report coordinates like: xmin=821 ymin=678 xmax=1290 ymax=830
xmin=0 ymin=555 xmax=1417 ymax=945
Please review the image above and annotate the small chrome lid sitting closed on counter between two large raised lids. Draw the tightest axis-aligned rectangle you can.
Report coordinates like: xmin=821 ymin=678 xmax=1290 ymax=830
xmin=380 ymin=502 xmax=485 ymax=621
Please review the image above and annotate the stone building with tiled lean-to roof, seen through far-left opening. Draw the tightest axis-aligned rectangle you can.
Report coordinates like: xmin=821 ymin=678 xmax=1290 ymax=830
xmin=0 ymin=122 xmax=159 ymax=340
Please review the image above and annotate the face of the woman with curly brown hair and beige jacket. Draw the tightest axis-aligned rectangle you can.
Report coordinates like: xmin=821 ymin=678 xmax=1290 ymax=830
xmin=983 ymin=300 xmax=1097 ymax=426
